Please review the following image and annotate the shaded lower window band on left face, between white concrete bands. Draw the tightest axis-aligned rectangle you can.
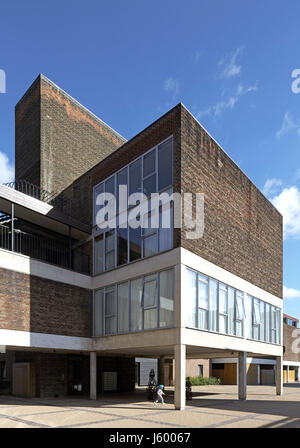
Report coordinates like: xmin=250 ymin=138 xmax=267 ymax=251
xmin=94 ymin=269 xmax=174 ymax=336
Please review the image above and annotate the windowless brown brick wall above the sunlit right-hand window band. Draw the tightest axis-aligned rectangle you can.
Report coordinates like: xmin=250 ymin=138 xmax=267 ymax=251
xmin=181 ymin=107 xmax=282 ymax=297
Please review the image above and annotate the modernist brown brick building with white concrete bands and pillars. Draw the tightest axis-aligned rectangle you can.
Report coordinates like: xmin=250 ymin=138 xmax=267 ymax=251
xmin=0 ymin=76 xmax=283 ymax=409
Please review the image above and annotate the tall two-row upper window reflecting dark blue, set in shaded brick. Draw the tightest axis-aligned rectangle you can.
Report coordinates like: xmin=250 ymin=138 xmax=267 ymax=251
xmin=93 ymin=138 xmax=173 ymax=274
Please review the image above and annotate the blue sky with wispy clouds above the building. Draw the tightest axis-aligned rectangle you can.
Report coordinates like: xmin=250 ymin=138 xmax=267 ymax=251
xmin=0 ymin=0 xmax=300 ymax=318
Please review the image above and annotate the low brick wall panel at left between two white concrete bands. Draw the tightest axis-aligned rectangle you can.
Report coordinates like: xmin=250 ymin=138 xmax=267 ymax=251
xmin=0 ymin=269 xmax=92 ymax=337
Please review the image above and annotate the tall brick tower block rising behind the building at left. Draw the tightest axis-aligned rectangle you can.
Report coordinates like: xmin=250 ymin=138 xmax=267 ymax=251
xmin=15 ymin=75 xmax=125 ymax=197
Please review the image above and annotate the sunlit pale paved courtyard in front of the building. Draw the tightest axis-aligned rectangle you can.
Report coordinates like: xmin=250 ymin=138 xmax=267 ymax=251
xmin=0 ymin=384 xmax=300 ymax=429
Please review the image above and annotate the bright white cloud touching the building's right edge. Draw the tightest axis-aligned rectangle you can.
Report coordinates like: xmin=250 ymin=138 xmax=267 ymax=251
xmin=270 ymin=186 xmax=300 ymax=239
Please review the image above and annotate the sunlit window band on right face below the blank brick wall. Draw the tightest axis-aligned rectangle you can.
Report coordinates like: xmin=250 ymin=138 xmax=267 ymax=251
xmin=183 ymin=268 xmax=281 ymax=344
